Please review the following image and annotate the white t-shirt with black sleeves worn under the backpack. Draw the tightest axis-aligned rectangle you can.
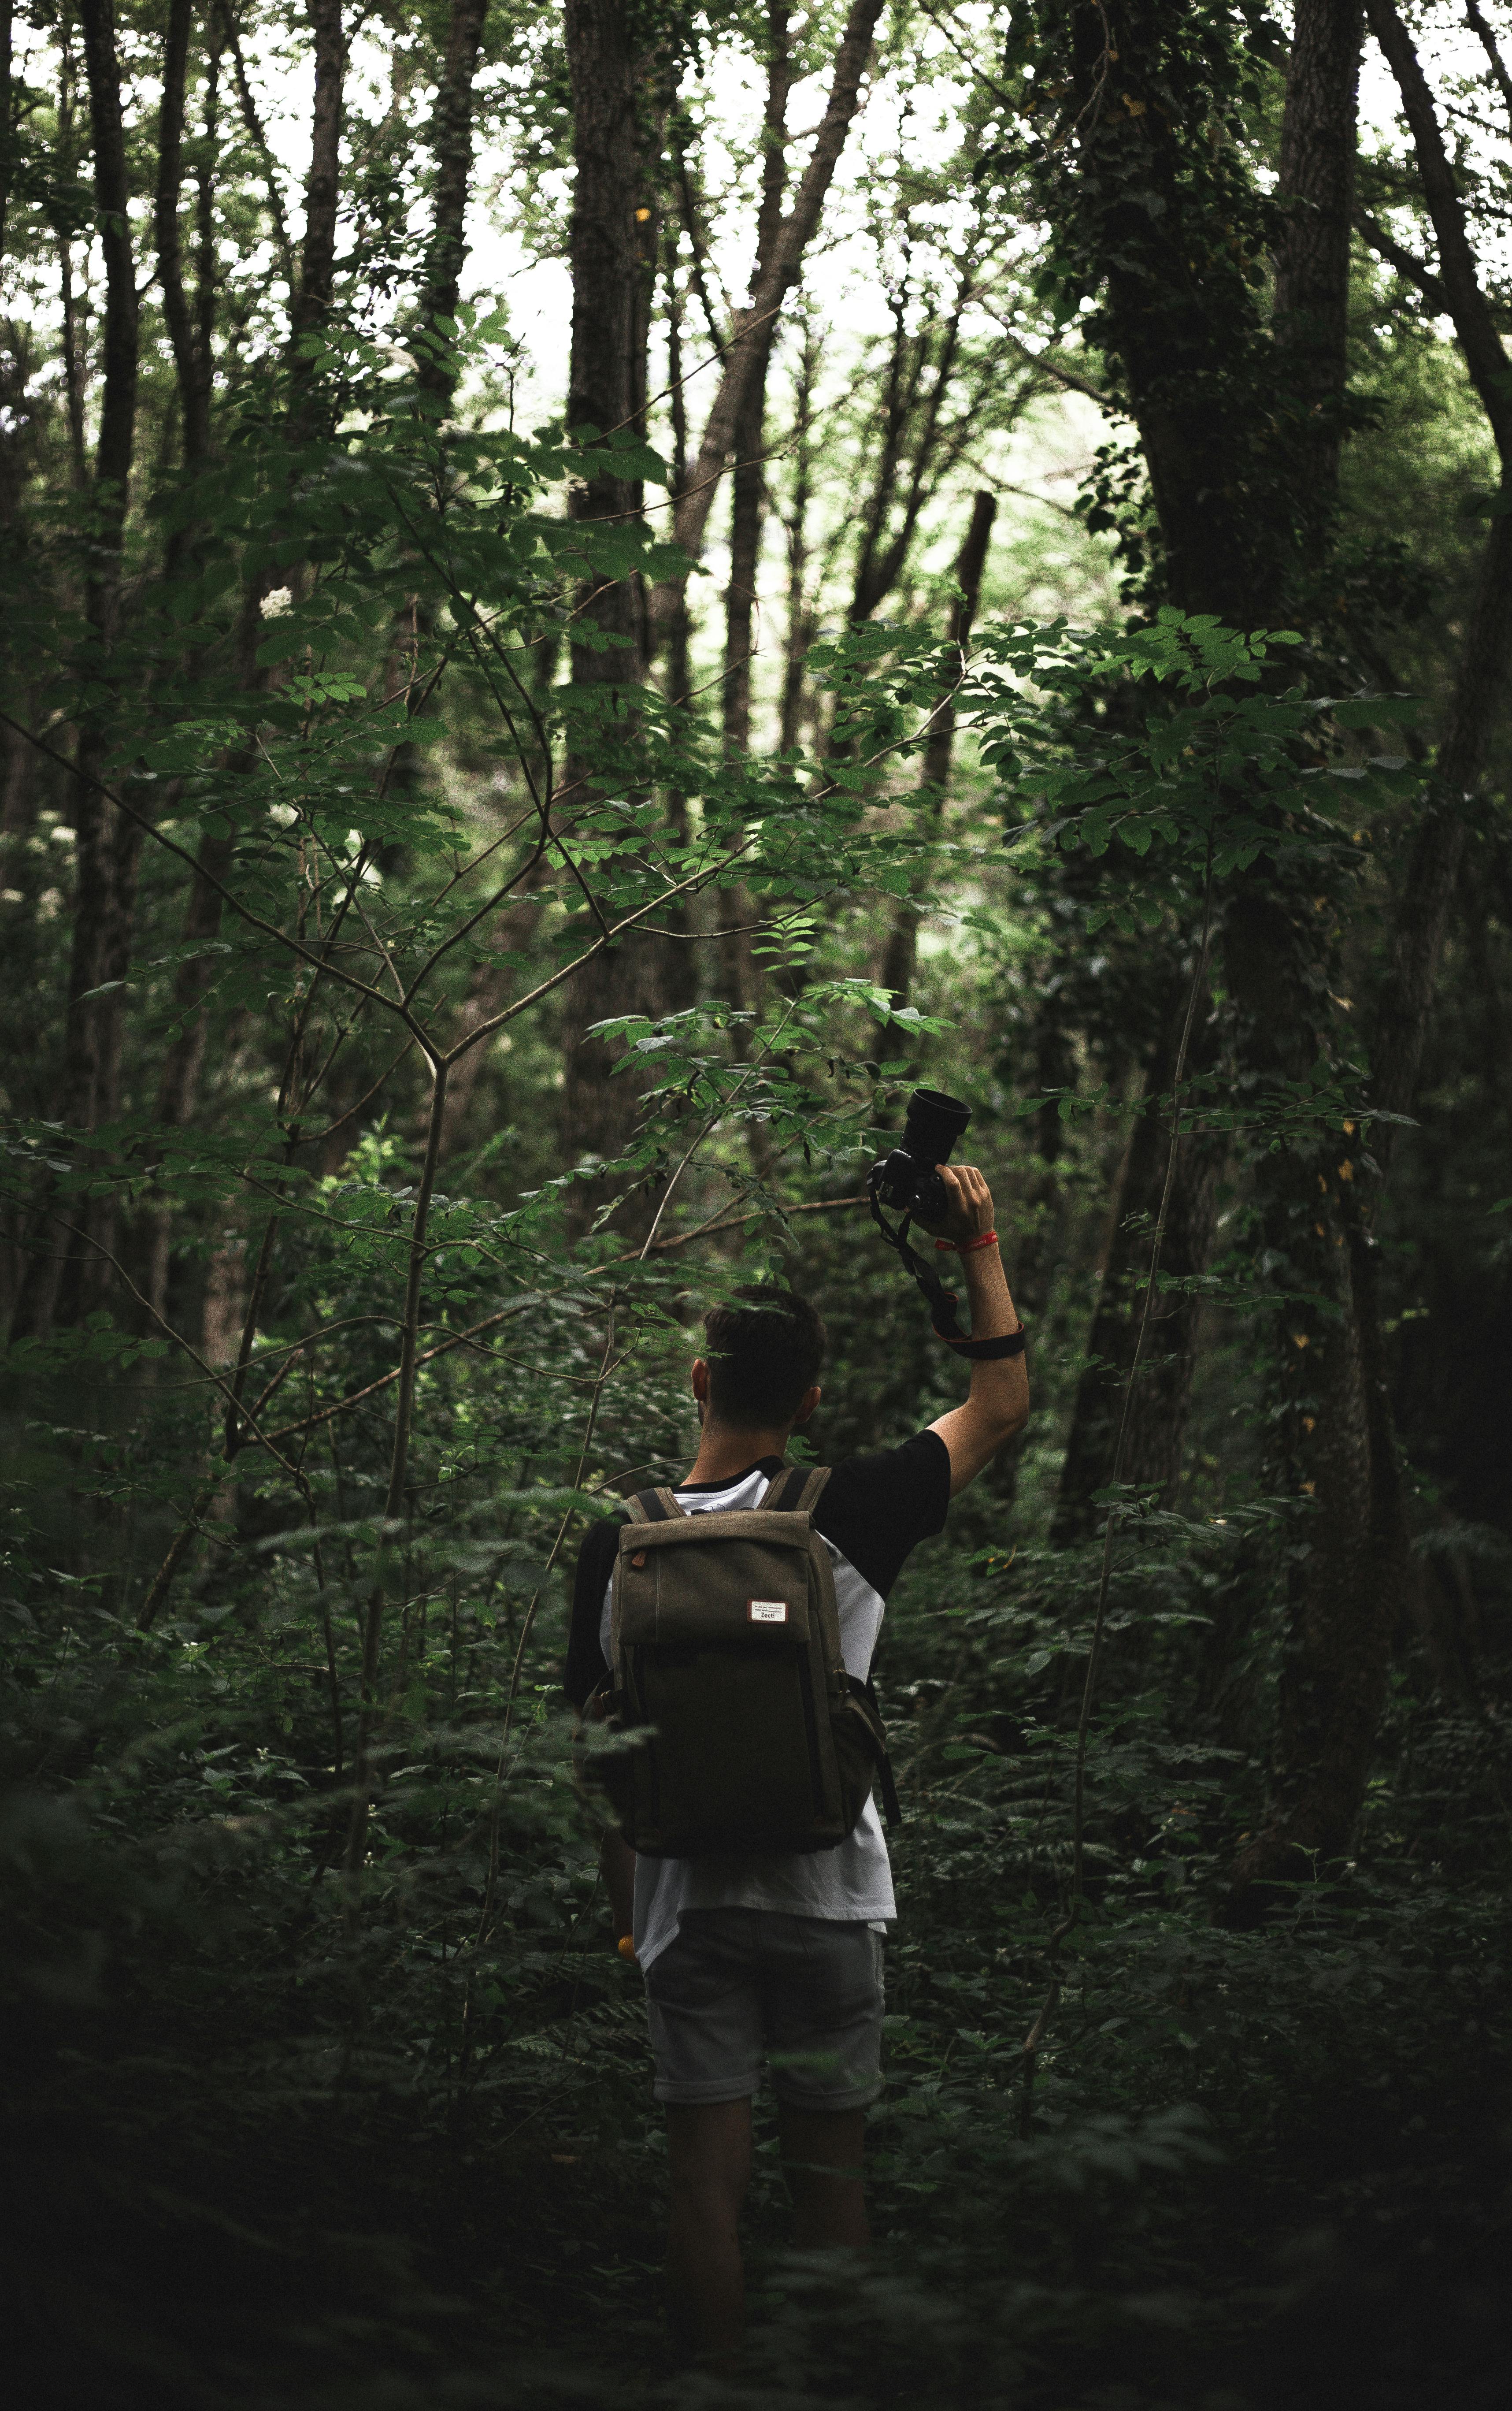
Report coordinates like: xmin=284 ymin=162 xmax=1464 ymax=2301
xmin=567 ymin=1432 xmax=950 ymax=1967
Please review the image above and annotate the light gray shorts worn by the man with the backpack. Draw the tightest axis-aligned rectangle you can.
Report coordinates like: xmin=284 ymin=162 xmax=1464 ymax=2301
xmin=646 ymin=1909 xmax=882 ymax=2110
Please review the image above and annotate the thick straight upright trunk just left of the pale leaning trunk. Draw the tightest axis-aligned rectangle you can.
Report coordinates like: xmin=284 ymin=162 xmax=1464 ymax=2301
xmin=562 ymin=0 xmax=658 ymax=1232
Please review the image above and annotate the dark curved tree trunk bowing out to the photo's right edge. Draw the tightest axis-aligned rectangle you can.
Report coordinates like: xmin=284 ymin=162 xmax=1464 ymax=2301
xmin=1230 ymin=0 xmax=1512 ymax=1919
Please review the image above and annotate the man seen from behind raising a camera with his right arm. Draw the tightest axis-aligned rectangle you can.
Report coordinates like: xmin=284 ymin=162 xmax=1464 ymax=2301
xmin=567 ymin=1164 xmax=1030 ymax=2355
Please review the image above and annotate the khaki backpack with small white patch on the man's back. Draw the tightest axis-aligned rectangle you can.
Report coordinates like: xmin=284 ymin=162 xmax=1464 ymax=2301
xmin=579 ymin=1466 xmax=897 ymax=1859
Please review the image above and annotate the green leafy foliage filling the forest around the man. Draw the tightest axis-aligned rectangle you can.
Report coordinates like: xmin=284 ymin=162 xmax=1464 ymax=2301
xmin=0 ymin=0 xmax=1512 ymax=2411
